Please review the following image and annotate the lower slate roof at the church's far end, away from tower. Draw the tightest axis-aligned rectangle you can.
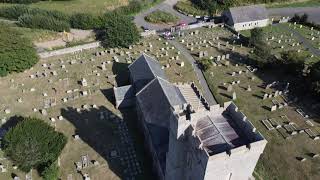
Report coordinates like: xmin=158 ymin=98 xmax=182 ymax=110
xmin=128 ymin=54 xmax=166 ymax=86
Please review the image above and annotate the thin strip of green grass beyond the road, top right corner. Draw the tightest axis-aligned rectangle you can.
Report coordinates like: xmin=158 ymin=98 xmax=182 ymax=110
xmin=266 ymin=0 xmax=320 ymax=8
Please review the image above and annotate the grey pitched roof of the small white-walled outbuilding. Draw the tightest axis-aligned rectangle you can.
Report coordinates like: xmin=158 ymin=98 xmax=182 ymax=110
xmin=229 ymin=5 xmax=268 ymax=24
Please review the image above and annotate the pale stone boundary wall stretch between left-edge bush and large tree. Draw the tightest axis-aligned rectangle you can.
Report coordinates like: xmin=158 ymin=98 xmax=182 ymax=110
xmin=38 ymin=41 xmax=101 ymax=58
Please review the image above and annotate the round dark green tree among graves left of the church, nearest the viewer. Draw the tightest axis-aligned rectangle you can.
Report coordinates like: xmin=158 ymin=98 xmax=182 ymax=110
xmin=3 ymin=118 xmax=67 ymax=172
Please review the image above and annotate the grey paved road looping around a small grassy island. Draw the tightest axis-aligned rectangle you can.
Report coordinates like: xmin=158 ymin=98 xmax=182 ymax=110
xmin=134 ymin=0 xmax=197 ymax=30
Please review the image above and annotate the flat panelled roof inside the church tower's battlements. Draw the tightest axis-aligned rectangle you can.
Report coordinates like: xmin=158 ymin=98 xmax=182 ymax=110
xmin=196 ymin=114 xmax=248 ymax=155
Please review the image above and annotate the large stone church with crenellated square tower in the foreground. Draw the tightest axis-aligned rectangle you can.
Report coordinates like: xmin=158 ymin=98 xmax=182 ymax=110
xmin=114 ymin=54 xmax=267 ymax=180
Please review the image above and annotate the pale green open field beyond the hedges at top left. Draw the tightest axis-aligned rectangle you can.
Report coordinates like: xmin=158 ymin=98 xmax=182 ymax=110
xmin=0 ymin=0 xmax=129 ymax=14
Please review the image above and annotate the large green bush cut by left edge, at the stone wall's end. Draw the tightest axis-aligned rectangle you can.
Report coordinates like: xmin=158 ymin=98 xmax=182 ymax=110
xmin=0 ymin=23 xmax=38 ymax=76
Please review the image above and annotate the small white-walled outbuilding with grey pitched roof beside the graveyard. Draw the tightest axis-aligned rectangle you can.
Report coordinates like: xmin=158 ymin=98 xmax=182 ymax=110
xmin=222 ymin=5 xmax=269 ymax=31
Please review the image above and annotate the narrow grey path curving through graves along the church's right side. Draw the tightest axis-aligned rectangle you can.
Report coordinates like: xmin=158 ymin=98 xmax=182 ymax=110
xmin=169 ymin=40 xmax=217 ymax=105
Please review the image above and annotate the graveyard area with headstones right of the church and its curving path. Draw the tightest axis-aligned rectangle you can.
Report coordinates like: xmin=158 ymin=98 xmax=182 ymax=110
xmin=178 ymin=26 xmax=320 ymax=179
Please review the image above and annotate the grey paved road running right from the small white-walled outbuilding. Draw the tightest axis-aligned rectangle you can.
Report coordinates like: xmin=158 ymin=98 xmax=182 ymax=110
xmin=268 ymin=7 xmax=320 ymax=24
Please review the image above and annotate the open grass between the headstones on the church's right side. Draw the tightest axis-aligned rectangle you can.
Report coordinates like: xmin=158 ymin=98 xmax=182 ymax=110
xmin=179 ymin=27 xmax=320 ymax=180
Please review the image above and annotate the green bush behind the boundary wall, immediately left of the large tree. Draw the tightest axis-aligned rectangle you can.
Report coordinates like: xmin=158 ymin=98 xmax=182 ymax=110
xmin=70 ymin=13 xmax=101 ymax=29
